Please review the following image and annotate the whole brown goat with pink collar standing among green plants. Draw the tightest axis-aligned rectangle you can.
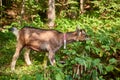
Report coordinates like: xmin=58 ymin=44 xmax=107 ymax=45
xmin=11 ymin=27 xmax=87 ymax=70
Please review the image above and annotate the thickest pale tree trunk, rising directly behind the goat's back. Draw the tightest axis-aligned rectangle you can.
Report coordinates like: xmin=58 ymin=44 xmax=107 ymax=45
xmin=47 ymin=0 xmax=55 ymax=28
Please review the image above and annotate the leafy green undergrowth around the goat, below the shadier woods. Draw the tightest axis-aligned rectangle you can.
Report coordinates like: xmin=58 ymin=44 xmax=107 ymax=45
xmin=0 ymin=15 xmax=120 ymax=80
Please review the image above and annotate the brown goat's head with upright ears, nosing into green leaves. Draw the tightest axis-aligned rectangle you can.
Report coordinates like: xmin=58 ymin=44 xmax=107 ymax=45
xmin=76 ymin=27 xmax=89 ymax=41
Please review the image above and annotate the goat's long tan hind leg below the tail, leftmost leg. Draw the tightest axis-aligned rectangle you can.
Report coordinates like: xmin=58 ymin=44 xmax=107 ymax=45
xmin=11 ymin=43 xmax=23 ymax=71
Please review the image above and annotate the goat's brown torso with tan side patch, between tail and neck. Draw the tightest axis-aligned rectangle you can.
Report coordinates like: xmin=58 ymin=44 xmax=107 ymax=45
xmin=18 ymin=27 xmax=62 ymax=51
